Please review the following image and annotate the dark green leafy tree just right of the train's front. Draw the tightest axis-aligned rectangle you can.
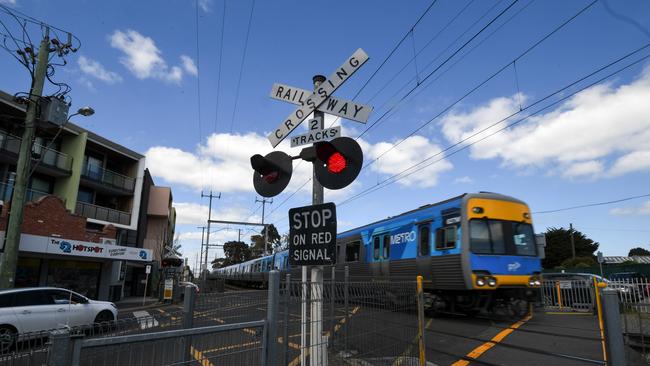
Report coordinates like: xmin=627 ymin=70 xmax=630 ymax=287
xmin=542 ymin=227 xmax=599 ymax=268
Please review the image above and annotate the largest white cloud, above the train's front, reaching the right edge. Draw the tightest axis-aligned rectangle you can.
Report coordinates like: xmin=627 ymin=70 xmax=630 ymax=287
xmin=441 ymin=68 xmax=650 ymax=178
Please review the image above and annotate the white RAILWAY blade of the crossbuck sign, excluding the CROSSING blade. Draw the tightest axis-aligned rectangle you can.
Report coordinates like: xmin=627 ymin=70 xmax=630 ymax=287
xmin=271 ymin=83 xmax=372 ymax=123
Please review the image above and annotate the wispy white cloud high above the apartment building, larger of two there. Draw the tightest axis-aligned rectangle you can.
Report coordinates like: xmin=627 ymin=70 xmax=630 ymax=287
xmin=109 ymin=29 xmax=189 ymax=83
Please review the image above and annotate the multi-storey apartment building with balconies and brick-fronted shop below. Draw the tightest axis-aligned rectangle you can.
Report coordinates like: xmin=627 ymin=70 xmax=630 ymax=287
xmin=0 ymin=91 xmax=175 ymax=301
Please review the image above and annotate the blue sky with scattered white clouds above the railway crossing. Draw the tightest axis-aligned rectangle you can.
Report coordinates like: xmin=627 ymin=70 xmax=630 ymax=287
xmin=0 ymin=0 xmax=650 ymax=266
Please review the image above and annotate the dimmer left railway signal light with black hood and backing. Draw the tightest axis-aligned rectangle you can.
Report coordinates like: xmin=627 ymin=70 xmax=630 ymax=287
xmin=251 ymin=151 xmax=293 ymax=197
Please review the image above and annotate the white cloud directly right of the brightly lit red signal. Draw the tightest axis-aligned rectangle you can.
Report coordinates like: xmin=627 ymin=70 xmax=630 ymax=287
xmin=361 ymin=135 xmax=453 ymax=188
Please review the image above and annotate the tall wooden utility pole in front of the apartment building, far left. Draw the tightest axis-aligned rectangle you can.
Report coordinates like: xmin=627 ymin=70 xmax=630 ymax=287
xmin=0 ymin=27 xmax=50 ymax=288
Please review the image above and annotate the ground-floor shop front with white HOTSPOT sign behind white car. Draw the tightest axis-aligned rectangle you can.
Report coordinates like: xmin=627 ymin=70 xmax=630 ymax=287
xmin=15 ymin=234 xmax=152 ymax=300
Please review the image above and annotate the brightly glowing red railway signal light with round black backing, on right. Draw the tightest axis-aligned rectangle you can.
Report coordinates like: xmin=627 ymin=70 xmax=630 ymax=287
xmin=300 ymin=137 xmax=363 ymax=189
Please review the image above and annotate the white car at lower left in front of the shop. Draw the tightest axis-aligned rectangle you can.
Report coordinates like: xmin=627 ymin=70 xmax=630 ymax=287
xmin=0 ymin=287 xmax=117 ymax=350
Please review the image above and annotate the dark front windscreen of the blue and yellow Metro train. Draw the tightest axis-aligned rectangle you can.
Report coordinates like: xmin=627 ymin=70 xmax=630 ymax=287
xmin=469 ymin=219 xmax=537 ymax=256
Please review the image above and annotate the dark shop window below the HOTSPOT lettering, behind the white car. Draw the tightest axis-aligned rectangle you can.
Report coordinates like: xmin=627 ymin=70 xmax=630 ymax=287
xmin=47 ymin=260 xmax=102 ymax=299
